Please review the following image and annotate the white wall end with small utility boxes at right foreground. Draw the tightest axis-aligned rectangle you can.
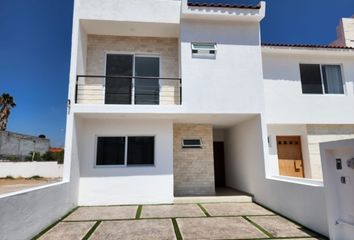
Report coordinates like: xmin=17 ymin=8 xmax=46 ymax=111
xmin=321 ymin=139 xmax=354 ymax=240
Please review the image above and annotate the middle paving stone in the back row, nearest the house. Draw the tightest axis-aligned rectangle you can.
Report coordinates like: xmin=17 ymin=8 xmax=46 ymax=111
xmin=141 ymin=204 xmax=205 ymax=218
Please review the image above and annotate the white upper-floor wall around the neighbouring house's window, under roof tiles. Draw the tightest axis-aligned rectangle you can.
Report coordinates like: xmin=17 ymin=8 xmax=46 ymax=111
xmin=263 ymin=50 xmax=354 ymax=124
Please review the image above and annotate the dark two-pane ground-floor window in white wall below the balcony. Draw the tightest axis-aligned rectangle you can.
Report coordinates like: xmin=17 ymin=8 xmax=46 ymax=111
xmin=96 ymin=136 xmax=155 ymax=166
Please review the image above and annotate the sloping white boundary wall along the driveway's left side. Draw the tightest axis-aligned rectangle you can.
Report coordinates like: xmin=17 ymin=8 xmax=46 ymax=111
xmin=0 ymin=116 xmax=78 ymax=240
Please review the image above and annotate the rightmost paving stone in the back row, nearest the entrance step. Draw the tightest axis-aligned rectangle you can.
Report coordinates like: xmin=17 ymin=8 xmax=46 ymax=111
xmin=202 ymin=203 xmax=274 ymax=216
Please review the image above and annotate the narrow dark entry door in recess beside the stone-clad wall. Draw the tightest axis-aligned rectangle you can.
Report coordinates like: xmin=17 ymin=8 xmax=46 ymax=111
xmin=213 ymin=142 xmax=225 ymax=187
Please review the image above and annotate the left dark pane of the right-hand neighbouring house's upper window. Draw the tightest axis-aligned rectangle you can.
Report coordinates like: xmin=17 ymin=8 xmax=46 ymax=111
xmin=300 ymin=64 xmax=323 ymax=94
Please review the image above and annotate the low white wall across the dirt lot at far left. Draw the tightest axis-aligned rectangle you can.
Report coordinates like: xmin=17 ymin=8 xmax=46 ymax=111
xmin=0 ymin=162 xmax=63 ymax=178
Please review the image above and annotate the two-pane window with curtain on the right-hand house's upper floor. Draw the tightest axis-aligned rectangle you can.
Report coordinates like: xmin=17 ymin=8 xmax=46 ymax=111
xmin=300 ymin=64 xmax=344 ymax=94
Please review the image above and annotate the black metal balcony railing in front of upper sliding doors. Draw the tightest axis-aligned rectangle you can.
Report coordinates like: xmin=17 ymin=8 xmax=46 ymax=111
xmin=75 ymin=75 xmax=182 ymax=105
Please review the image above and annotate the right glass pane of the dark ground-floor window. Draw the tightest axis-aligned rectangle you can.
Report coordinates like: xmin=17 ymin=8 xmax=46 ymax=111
xmin=127 ymin=137 xmax=155 ymax=165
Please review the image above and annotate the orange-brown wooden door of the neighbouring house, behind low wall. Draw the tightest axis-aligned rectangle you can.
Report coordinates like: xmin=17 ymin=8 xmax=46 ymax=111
xmin=277 ymin=136 xmax=305 ymax=178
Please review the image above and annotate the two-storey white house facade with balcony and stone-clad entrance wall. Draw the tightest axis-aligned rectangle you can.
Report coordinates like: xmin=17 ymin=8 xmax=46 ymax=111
xmin=69 ymin=1 xmax=266 ymax=205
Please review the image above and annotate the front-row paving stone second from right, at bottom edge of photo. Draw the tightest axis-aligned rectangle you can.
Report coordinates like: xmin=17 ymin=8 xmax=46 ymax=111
xmin=177 ymin=217 xmax=267 ymax=239
